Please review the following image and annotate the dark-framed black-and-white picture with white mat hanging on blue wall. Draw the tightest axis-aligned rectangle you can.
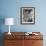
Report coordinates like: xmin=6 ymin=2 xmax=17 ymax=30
xmin=20 ymin=7 xmax=35 ymax=24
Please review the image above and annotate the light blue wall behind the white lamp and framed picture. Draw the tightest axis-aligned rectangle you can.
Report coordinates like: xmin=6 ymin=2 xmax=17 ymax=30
xmin=0 ymin=0 xmax=46 ymax=45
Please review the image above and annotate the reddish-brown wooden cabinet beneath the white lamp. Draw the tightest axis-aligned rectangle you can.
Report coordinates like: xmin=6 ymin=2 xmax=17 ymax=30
xmin=4 ymin=32 xmax=43 ymax=46
